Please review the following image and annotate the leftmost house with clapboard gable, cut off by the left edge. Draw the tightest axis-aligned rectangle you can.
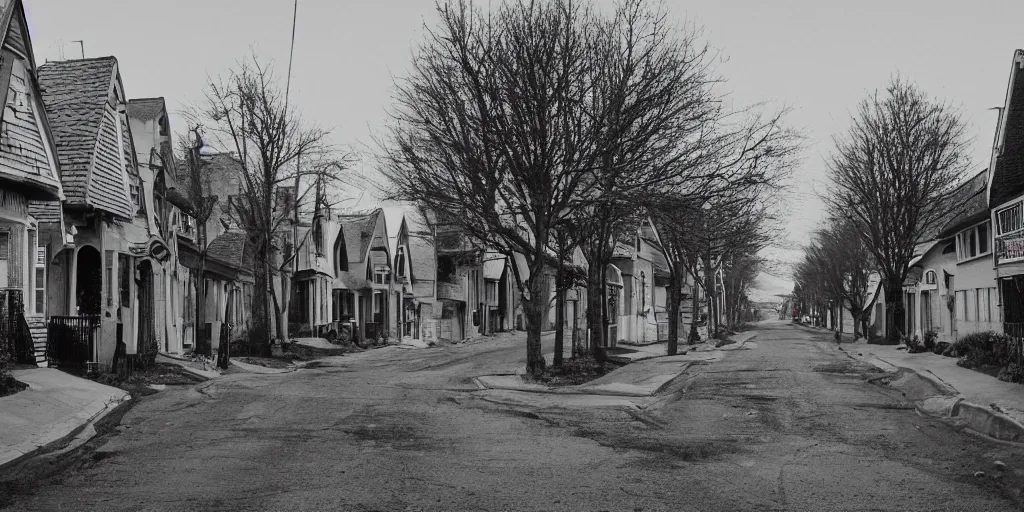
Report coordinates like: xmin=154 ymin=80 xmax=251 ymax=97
xmin=0 ymin=0 xmax=68 ymax=366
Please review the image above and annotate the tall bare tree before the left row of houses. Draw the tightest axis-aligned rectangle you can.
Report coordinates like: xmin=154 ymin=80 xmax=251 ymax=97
xmin=202 ymin=56 xmax=346 ymax=352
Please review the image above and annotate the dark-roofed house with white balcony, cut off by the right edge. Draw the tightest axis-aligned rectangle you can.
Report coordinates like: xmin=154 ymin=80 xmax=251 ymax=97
xmin=987 ymin=49 xmax=1024 ymax=339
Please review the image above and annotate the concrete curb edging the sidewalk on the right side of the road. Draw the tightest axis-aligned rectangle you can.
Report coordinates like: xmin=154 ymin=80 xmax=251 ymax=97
xmin=842 ymin=344 xmax=1024 ymax=443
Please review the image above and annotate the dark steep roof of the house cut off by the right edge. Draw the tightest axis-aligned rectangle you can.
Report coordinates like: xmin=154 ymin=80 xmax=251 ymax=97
xmin=988 ymin=49 xmax=1024 ymax=207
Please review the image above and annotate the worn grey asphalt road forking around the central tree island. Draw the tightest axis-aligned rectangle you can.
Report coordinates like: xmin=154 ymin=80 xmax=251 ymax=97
xmin=0 ymin=323 xmax=1024 ymax=511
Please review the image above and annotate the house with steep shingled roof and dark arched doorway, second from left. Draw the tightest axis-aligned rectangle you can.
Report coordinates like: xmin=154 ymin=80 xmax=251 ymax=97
xmin=38 ymin=56 xmax=159 ymax=368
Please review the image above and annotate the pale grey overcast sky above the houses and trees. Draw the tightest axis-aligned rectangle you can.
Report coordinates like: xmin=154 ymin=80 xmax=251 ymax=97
xmin=25 ymin=0 xmax=1024 ymax=299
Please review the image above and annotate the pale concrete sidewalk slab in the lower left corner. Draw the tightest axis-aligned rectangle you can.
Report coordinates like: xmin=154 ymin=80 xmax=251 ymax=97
xmin=0 ymin=368 xmax=131 ymax=466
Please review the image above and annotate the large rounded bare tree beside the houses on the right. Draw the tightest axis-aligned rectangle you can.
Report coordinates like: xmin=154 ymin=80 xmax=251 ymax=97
xmin=825 ymin=78 xmax=971 ymax=343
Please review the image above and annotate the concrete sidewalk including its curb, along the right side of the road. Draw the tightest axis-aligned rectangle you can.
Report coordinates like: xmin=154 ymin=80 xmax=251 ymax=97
xmin=842 ymin=343 xmax=1024 ymax=442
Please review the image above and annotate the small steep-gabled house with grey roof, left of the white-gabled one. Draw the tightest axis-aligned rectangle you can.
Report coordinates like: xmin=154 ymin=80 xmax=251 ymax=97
xmin=332 ymin=208 xmax=397 ymax=340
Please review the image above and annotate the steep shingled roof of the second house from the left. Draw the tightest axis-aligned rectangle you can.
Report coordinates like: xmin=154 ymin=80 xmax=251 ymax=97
xmin=39 ymin=56 xmax=134 ymax=218
